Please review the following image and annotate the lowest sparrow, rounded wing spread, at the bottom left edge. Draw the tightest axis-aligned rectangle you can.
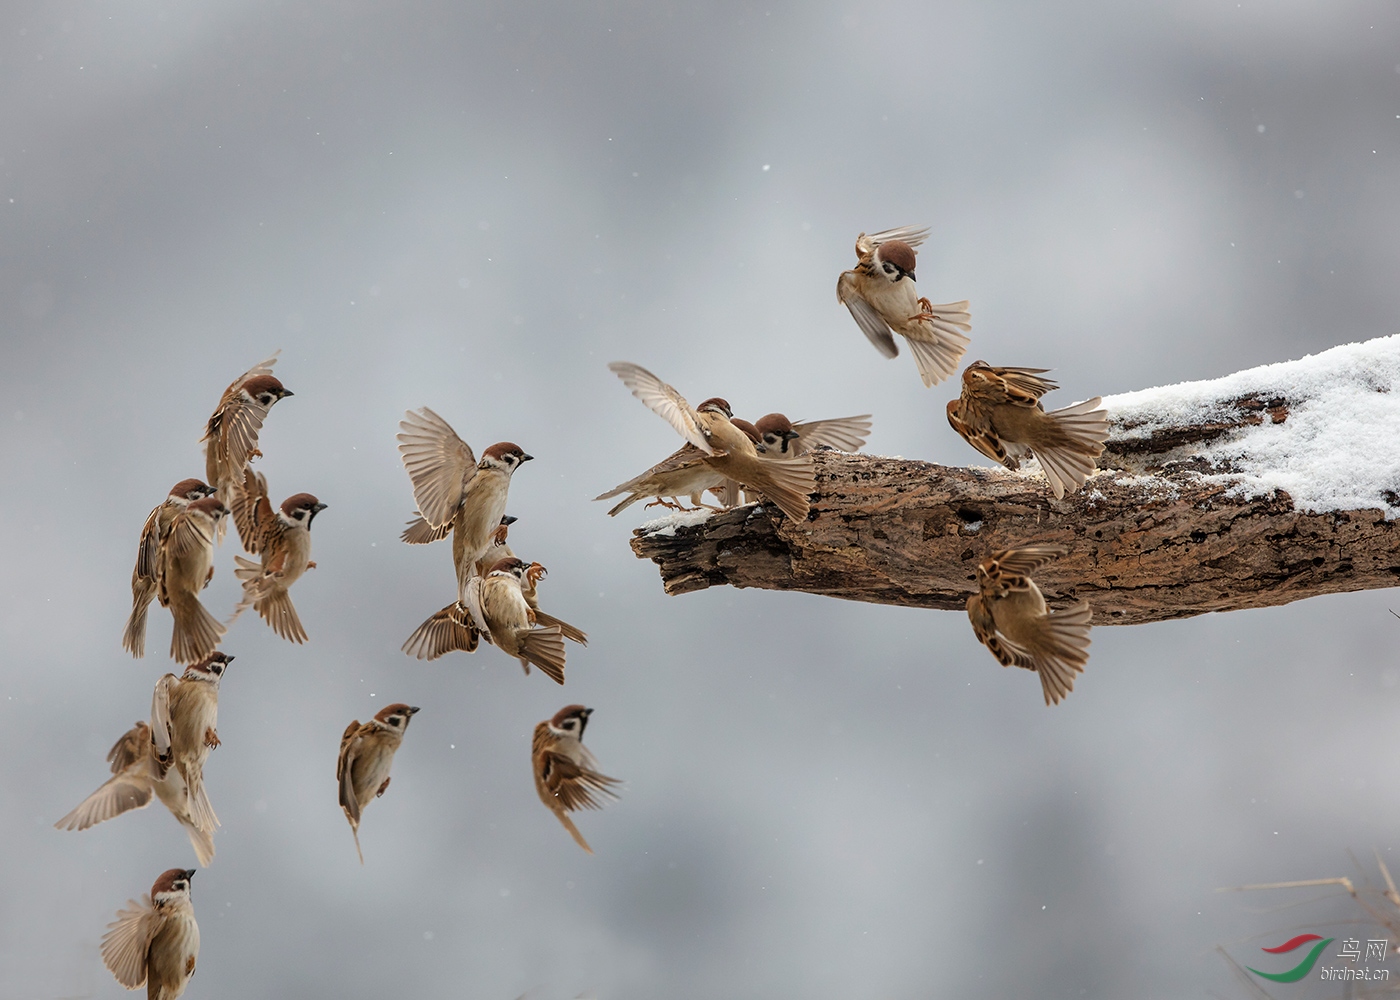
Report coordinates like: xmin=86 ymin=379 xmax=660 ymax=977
xmin=102 ymin=868 xmax=199 ymax=1000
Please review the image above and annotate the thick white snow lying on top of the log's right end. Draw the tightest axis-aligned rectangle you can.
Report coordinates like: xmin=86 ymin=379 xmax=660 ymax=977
xmin=1103 ymin=335 xmax=1400 ymax=518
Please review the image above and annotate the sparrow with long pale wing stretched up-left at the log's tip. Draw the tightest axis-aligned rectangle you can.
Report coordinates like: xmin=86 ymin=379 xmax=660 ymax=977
xmin=608 ymin=361 xmax=816 ymax=521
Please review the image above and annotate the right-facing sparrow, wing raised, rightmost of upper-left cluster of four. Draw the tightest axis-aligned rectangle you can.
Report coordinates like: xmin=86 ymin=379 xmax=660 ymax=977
xmin=228 ymin=469 xmax=326 ymax=643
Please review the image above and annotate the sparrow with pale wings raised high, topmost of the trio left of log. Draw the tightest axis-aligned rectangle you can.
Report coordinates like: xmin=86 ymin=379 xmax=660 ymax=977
xmin=398 ymin=406 xmax=533 ymax=599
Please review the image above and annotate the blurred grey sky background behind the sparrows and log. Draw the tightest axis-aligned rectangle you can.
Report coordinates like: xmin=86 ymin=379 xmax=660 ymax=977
xmin=0 ymin=0 xmax=1400 ymax=1000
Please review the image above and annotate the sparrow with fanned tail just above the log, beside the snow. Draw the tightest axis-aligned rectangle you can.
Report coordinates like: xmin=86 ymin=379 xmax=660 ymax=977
xmin=948 ymin=361 xmax=1109 ymax=500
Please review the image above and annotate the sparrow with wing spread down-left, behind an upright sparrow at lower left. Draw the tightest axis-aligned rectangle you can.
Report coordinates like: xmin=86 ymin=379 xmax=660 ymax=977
xmin=53 ymin=723 xmax=214 ymax=868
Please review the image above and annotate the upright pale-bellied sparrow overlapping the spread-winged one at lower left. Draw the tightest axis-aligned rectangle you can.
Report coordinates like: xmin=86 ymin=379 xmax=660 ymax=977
xmin=151 ymin=651 xmax=234 ymax=832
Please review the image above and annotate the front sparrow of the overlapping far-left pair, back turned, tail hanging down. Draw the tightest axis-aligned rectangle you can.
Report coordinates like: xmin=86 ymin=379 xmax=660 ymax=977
xmin=155 ymin=496 xmax=228 ymax=664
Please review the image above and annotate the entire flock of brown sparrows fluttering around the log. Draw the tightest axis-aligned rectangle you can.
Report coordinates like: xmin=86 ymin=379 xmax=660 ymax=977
xmin=56 ymin=227 xmax=1107 ymax=1000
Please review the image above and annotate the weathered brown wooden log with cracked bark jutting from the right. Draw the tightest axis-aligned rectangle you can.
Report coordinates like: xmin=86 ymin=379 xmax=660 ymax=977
xmin=631 ymin=338 xmax=1400 ymax=625
